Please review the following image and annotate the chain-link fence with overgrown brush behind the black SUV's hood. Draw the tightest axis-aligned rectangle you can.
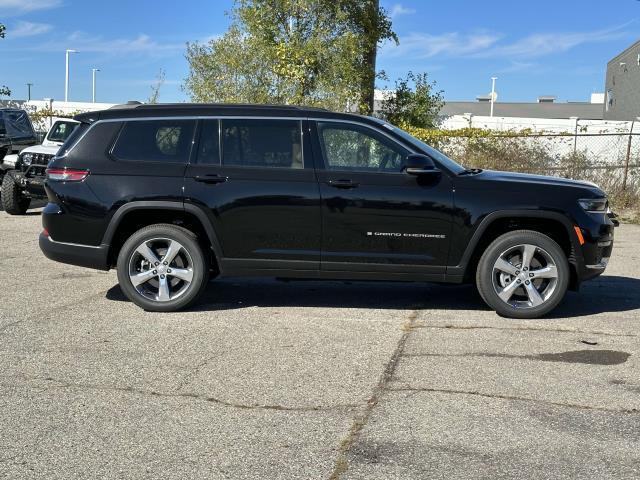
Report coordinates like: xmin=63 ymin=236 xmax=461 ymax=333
xmin=420 ymin=130 xmax=640 ymax=215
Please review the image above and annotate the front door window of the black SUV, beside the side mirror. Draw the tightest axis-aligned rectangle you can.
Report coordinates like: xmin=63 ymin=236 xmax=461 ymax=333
xmin=318 ymin=123 xmax=407 ymax=172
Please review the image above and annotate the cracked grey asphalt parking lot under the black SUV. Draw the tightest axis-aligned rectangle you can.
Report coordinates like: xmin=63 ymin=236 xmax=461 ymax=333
xmin=0 ymin=212 xmax=640 ymax=479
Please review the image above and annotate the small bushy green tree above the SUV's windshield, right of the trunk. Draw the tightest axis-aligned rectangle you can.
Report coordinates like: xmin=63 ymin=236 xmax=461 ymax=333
xmin=380 ymin=72 xmax=444 ymax=128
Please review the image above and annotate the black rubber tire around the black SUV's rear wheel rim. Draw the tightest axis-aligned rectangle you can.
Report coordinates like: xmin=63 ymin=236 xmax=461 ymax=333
xmin=117 ymin=224 xmax=209 ymax=312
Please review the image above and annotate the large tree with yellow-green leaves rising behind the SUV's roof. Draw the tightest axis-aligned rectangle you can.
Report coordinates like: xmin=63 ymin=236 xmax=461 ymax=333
xmin=185 ymin=0 xmax=390 ymax=110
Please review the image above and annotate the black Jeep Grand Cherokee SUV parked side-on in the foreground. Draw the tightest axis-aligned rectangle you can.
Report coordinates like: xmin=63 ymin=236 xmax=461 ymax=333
xmin=40 ymin=104 xmax=616 ymax=318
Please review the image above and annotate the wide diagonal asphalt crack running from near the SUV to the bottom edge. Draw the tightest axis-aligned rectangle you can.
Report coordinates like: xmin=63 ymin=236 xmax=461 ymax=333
xmin=329 ymin=310 xmax=418 ymax=480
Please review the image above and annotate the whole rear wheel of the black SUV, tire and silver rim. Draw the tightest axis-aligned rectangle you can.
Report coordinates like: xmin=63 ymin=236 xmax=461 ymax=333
xmin=117 ymin=224 xmax=210 ymax=312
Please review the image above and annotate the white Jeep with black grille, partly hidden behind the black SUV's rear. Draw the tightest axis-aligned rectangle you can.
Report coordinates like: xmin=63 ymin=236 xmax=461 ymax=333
xmin=2 ymin=118 xmax=80 ymax=215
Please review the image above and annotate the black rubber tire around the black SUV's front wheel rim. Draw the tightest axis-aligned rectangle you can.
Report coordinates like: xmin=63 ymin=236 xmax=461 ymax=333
xmin=476 ymin=230 xmax=570 ymax=319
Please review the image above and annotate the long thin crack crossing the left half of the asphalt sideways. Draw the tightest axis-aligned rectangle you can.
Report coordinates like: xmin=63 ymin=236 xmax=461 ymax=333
xmin=0 ymin=377 xmax=362 ymax=412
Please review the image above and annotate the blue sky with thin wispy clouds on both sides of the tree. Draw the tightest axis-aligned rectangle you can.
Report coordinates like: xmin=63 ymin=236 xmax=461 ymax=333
xmin=0 ymin=0 xmax=640 ymax=102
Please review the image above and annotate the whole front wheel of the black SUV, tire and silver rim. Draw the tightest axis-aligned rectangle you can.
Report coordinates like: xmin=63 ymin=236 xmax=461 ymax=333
xmin=476 ymin=230 xmax=570 ymax=319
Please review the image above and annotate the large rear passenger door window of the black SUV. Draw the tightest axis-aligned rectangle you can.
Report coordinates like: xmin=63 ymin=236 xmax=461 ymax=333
xmin=222 ymin=120 xmax=303 ymax=168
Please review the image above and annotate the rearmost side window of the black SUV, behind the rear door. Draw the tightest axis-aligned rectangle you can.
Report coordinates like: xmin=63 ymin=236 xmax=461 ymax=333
xmin=113 ymin=120 xmax=195 ymax=163
